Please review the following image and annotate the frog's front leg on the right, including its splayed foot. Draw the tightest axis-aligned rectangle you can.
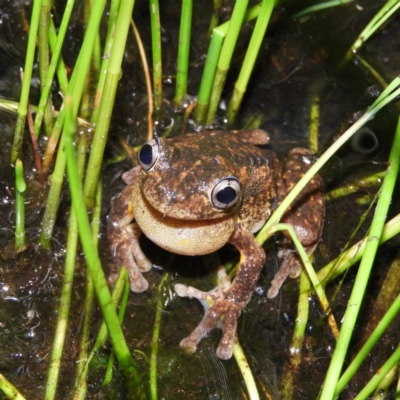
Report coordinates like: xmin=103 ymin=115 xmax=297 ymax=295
xmin=175 ymin=223 xmax=265 ymax=360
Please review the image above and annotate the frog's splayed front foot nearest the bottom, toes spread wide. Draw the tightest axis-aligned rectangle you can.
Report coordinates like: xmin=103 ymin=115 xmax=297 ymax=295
xmin=174 ymin=268 xmax=238 ymax=360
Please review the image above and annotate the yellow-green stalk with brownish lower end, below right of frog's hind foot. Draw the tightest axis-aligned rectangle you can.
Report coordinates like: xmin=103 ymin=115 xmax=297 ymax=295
xmin=282 ymin=270 xmax=311 ymax=400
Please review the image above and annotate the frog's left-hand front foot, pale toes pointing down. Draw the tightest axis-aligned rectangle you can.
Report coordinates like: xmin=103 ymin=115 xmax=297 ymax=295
xmin=108 ymin=224 xmax=152 ymax=293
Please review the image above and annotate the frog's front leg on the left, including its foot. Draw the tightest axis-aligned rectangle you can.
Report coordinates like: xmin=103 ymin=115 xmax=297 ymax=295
xmin=107 ymin=183 xmax=152 ymax=293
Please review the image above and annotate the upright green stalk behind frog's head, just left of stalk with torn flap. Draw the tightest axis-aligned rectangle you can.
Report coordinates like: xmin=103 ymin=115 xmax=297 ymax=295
xmin=174 ymin=0 xmax=192 ymax=106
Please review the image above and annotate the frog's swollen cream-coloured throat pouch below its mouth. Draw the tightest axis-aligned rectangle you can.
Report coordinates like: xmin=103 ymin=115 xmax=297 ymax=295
xmin=132 ymin=184 xmax=235 ymax=256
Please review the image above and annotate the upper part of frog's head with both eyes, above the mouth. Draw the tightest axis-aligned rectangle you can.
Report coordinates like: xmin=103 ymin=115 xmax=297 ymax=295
xmin=138 ymin=135 xmax=243 ymax=220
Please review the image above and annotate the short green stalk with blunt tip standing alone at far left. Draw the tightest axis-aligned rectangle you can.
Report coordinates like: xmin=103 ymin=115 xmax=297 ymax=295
xmin=15 ymin=159 xmax=26 ymax=252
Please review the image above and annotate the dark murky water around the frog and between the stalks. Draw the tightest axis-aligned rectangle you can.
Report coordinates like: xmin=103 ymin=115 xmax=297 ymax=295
xmin=0 ymin=0 xmax=400 ymax=399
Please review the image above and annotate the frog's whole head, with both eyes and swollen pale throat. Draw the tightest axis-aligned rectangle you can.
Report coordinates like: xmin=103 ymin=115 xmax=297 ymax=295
xmin=133 ymin=135 xmax=247 ymax=255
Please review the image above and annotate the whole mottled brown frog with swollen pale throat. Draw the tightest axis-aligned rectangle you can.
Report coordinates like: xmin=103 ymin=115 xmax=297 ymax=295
xmin=107 ymin=130 xmax=324 ymax=359
